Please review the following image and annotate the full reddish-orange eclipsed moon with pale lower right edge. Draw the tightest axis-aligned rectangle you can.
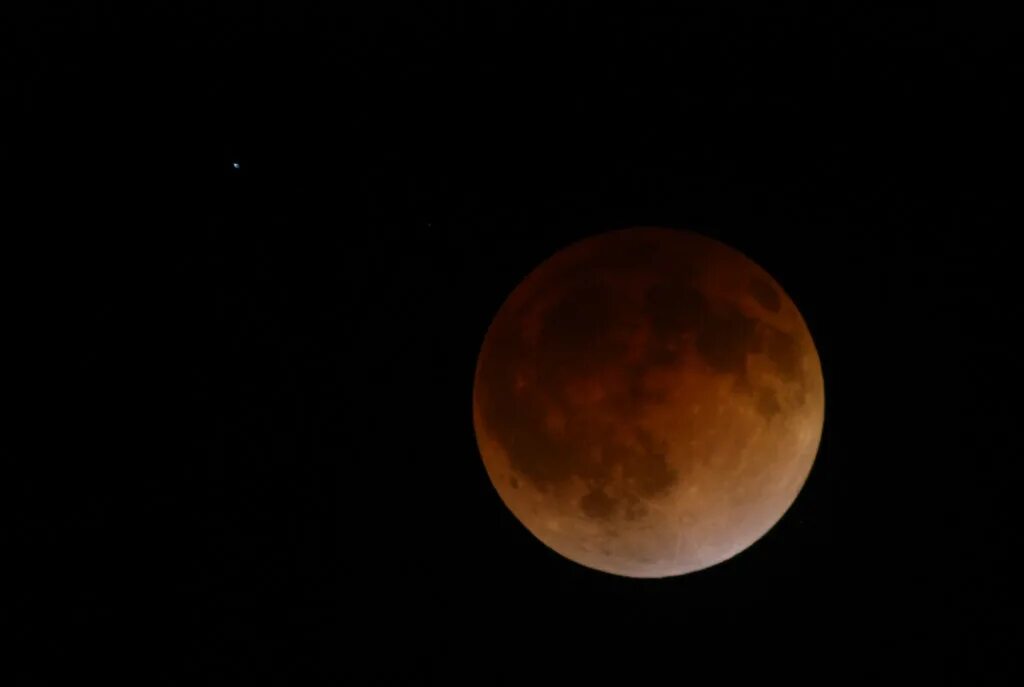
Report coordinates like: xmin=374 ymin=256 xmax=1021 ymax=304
xmin=473 ymin=227 xmax=824 ymax=577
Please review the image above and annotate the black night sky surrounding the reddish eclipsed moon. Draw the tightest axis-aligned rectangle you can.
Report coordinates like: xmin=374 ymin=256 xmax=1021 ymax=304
xmin=12 ymin=0 xmax=1022 ymax=685
